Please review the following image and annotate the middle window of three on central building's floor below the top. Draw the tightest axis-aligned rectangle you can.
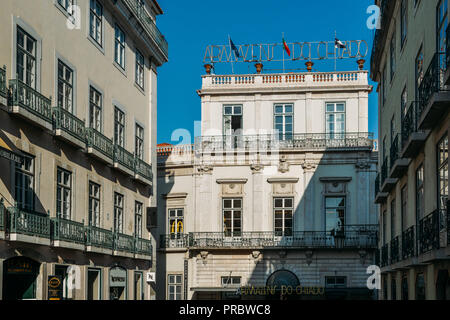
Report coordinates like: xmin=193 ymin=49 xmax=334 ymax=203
xmin=273 ymin=198 xmax=294 ymax=237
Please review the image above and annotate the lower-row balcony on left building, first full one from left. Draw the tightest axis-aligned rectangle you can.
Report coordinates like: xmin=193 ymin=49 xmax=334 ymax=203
xmin=6 ymin=207 xmax=50 ymax=245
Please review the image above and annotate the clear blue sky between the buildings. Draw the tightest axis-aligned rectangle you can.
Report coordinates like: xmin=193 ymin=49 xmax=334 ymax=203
xmin=157 ymin=0 xmax=378 ymax=143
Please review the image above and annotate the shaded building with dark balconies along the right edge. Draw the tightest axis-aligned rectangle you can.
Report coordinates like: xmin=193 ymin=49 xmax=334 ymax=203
xmin=371 ymin=0 xmax=450 ymax=300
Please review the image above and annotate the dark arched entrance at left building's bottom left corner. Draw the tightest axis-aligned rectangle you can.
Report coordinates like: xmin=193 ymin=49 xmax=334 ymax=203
xmin=3 ymin=257 xmax=40 ymax=300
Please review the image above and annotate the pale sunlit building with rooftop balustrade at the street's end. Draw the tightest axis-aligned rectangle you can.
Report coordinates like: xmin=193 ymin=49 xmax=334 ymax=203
xmin=157 ymin=64 xmax=378 ymax=299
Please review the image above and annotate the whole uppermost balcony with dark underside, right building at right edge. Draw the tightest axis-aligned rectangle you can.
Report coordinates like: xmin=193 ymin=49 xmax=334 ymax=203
xmin=417 ymin=53 xmax=450 ymax=130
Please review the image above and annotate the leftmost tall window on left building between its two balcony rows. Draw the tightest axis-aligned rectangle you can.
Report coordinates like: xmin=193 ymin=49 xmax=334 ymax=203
xmin=15 ymin=155 xmax=34 ymax=211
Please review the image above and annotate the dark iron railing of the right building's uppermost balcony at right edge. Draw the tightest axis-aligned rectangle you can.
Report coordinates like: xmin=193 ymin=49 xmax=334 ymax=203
xmin=418 ymin=52 xmax=450 ymax=118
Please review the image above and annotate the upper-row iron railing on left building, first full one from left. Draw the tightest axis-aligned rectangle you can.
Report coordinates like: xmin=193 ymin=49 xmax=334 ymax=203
xmin=9 ymin=79 xmax=52 ymax=123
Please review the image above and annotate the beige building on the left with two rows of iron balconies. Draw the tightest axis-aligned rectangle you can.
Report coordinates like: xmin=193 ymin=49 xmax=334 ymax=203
xmin=0 ymin=0 xmax=168 ymax=300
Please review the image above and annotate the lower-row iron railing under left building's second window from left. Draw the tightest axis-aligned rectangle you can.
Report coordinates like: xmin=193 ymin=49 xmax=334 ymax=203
xmin=52 ymin=217 xmax=86 ymax=244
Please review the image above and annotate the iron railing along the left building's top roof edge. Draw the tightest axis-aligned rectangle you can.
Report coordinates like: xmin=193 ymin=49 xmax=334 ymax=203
xmin=123 ymin=0 xmax=169 ymax=58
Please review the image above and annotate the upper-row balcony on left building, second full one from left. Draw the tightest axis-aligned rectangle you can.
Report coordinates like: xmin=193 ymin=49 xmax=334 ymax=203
xmin=53 ymin=107 xmax=86 ymax=149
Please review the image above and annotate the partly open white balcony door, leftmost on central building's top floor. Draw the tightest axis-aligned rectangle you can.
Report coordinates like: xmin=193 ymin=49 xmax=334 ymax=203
xmin=223 ymin=105 xmax=243 ymax=148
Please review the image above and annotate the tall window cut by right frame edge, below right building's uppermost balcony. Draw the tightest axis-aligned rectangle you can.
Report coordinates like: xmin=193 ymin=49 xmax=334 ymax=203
xmin=437 ymin=133 xmax=450 ymax=230
